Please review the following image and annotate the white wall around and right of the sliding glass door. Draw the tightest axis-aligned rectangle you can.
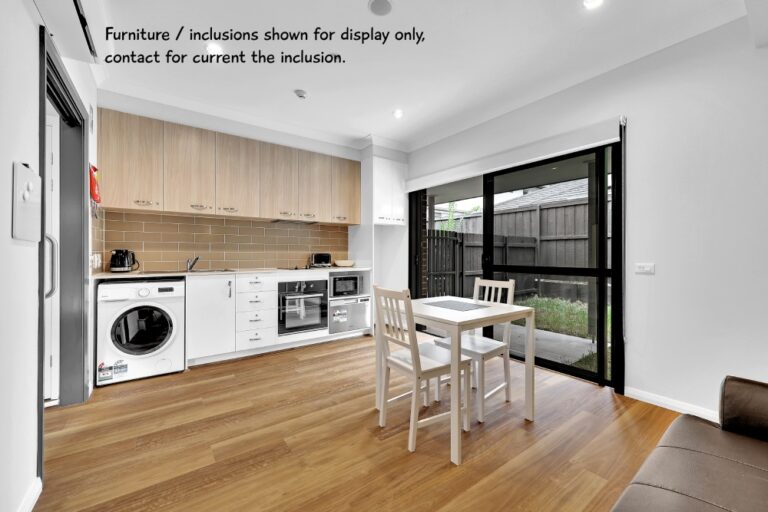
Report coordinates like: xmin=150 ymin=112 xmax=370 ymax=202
xmin=410 ymin=19 xmax=768 ymax=417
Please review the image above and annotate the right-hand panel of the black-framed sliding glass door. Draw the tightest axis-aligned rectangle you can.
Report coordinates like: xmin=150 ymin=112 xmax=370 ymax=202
xmin=483 ymin=146 xmax=620 ymax=384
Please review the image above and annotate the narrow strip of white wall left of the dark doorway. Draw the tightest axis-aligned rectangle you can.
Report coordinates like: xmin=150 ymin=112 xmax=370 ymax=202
xmin=0 ymin=0 xmax=44 ymax=511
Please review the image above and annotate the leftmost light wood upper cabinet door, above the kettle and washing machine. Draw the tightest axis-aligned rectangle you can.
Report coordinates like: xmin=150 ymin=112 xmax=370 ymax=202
xmin=98 ymin=108 xmax=163 ymax=210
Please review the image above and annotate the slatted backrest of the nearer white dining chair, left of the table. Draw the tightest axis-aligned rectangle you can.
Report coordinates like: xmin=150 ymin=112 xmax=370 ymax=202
xmin=373 ymin=285 xmax=421 ymax=375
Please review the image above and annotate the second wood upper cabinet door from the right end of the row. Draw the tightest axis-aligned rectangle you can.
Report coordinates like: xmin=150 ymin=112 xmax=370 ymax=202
xmin=298 ymin=151 xmax=333 ymax=222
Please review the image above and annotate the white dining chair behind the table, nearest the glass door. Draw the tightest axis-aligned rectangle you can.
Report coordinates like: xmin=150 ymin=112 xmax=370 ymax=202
xmin=435 ymin=278 xmax=515 ymax=423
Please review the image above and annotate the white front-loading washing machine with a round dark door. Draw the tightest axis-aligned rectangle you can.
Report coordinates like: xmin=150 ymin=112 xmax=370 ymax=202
xmin=96 ymin=280 xmax=186 ymax=386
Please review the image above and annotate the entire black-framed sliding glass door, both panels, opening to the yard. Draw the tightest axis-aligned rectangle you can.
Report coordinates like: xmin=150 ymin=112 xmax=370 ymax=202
xmin=411 ymin=143 xmax=623 ymax=392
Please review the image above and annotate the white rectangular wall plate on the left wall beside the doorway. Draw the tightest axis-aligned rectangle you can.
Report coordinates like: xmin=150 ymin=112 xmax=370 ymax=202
xmin=12 ymin=162 xmax=43 ymax=242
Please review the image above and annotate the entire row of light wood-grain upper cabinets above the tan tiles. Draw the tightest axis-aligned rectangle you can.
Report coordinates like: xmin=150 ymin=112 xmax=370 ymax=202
xmin=98 ymin=109 xmax=360 ymax=224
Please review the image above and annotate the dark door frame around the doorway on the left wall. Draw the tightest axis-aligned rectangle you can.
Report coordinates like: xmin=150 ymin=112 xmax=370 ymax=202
xmin=37 ymin=26 xmax=90 ymax=479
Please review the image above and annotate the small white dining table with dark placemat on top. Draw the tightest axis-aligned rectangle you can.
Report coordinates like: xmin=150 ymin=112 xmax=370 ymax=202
xmin=376 ymin=296 xmax=536 ymax=465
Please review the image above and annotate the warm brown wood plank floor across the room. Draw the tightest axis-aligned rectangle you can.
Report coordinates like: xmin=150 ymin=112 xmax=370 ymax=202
xmin=35 ymin=338 xmax=676 ymax=512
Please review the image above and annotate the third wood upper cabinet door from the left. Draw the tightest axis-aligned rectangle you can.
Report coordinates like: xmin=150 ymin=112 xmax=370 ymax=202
xmin=216 ymin=133 xmax=261 ymax=217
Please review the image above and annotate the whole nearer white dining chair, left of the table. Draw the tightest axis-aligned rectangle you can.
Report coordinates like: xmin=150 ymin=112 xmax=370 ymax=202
xmin=373 ymin=285 xmax=472 ymax=452
